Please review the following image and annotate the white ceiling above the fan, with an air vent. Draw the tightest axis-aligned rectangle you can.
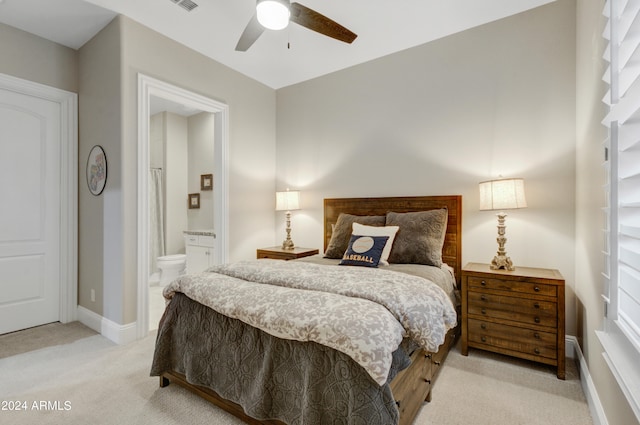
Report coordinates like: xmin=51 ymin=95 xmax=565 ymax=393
xmin=0 ymin=0 xmax=554 ymax=89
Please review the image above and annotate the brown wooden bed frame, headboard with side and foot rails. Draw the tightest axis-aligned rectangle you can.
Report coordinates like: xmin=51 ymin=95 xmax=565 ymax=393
xmin=160 ymin=195 xmax=462 ymax=425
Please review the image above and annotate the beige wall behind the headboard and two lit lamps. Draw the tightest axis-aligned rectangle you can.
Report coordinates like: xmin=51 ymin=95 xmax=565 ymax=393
xmin=276 ymin=0 xmax=576 ymax=335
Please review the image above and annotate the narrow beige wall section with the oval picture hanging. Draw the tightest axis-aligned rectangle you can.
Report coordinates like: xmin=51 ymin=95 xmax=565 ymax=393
xmin=78 ymin=20 xmax=124 ymax=323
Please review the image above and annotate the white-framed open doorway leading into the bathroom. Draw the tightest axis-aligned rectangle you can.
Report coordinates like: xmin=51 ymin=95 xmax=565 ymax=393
xmin=137 ymin=74 xmax=228 ymax=338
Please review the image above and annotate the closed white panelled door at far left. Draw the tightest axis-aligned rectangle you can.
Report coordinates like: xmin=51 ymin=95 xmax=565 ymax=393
xmin=0 ymin=88 xmax=62 ymax=334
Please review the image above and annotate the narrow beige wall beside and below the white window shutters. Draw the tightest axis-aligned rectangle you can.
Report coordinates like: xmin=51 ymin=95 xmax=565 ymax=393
xmin=575 ymin=0 xmax=638 ymax=425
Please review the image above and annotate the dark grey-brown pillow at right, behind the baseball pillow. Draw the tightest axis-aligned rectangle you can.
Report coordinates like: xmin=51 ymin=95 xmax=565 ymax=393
xmin=386 ymin=208 xmax=448 ymax=267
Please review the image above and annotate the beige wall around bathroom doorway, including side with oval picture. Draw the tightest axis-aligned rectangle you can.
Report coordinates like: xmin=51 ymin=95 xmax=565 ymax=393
xmin=79 ymin=16 xmax=275 ymax=324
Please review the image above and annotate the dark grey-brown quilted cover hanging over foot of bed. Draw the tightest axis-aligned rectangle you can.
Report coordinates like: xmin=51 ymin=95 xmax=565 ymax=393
xmin=151 ymin=293 xmax=410 ymax=425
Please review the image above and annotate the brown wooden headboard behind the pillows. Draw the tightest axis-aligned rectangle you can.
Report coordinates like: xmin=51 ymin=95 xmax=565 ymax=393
xmin=324 ymin=195 xmax=462 ymax=287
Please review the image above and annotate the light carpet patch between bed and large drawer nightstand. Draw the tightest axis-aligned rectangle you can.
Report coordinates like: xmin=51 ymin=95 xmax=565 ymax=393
xmin=415 ymin=343 xmax=593 ymax=425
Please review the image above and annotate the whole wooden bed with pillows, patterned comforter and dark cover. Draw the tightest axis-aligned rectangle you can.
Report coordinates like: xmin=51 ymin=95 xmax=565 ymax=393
xmin=151 ymin=195 xmax=462 ymax=425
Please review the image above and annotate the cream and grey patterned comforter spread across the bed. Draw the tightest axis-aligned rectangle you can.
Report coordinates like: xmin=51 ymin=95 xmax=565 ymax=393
xmin=164 ymin=260 xmax=456 ymax=385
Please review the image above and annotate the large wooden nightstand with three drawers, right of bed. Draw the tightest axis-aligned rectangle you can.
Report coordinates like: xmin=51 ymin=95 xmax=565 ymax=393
xmin=461 ymin=263 xmax=565 ymax=379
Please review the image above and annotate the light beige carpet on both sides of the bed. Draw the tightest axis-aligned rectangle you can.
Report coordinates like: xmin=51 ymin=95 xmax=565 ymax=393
xmin=0 ymin=323 xmax=592 ymax=425
